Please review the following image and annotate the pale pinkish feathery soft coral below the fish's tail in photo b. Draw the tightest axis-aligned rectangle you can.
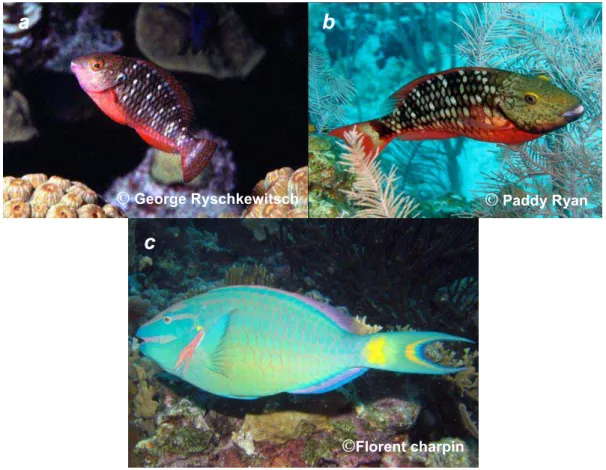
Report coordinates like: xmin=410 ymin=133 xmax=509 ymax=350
xmin=339 ymin=127 xmax=419 ymax=218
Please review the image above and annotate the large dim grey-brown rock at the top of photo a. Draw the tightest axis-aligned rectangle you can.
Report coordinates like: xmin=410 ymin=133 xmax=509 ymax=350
xmin=135 ymin=3 xmax=265 ymax=79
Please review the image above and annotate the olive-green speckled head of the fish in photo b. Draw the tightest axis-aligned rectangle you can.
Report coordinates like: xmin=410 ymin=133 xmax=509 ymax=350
xmin=499 ymin=72 xmax=585 ymax=134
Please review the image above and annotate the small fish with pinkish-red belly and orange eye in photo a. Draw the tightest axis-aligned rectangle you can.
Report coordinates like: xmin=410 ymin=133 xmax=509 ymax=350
xmin=71 ymin=54 xmax=217 ymax=183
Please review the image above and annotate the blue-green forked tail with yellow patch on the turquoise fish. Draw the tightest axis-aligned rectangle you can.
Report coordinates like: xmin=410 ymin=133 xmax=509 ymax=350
xmin=361 ymin=331 xmax=473 ymax=374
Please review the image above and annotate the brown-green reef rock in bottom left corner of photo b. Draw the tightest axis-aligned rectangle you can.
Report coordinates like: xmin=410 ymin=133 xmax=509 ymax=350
xmin=308 ymin=135 xmax=355 ymax=218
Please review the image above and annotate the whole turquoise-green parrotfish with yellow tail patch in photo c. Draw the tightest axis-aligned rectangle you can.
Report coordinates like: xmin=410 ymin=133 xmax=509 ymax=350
xmin=136 ymin=286 xmax=471 ymax=399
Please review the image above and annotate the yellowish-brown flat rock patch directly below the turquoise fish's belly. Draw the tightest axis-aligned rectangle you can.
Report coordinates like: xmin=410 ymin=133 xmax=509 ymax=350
xmin=240 ymin=411 xmax=329 ymax=444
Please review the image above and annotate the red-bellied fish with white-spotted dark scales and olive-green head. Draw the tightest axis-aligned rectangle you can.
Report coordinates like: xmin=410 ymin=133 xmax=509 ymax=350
xmin=329 ymin=67 xmax=584 ymax=158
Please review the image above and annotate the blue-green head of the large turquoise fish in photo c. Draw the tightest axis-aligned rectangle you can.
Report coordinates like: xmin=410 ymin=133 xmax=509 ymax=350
xmin=135 ymin=304 xmax=204 ymax=371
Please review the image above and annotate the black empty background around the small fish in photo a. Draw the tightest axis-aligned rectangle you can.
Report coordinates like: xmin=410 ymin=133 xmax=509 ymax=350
xmin=4 ymin=4 xmax=307 ymax=194
